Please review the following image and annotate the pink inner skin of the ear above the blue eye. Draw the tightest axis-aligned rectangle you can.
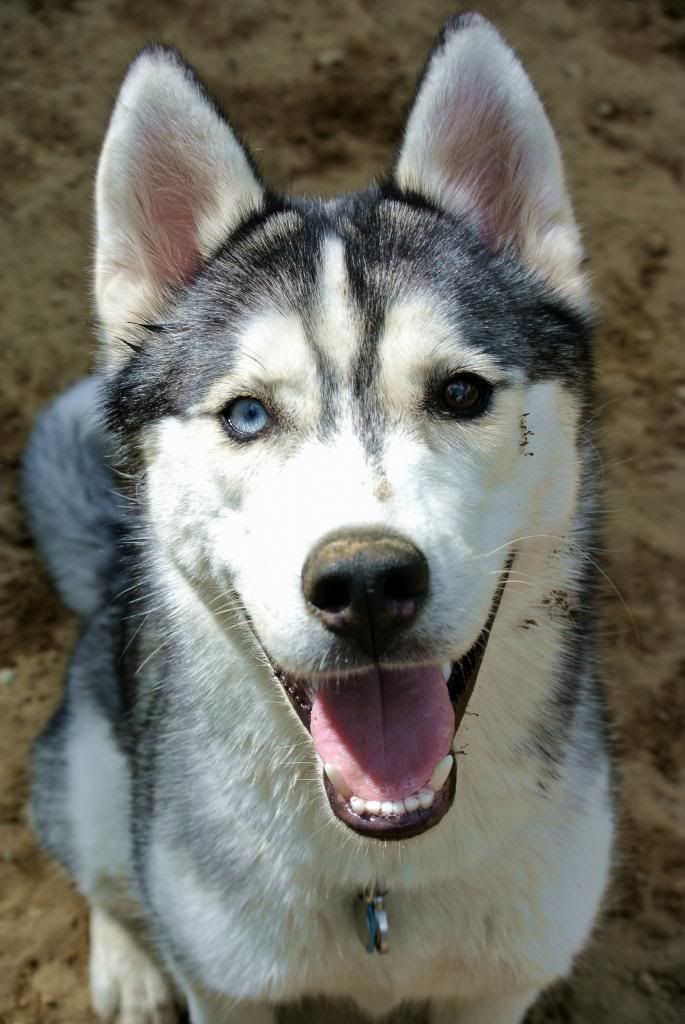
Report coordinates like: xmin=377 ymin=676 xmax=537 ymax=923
xmin=138 ymin=140 xmax=203 ymax=285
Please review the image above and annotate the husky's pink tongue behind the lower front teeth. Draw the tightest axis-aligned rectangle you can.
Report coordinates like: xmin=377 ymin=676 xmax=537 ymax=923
xmin=311 ymin=666 xmax=455 ymax=800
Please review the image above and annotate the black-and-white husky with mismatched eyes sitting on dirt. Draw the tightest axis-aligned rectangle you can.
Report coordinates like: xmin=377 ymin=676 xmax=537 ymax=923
xmin=25 ymin=14 xmax=613 ymax=1024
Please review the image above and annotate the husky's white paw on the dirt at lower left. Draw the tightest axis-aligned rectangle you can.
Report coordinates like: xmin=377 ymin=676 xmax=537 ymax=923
xmin=90 ymin=909 xmax=179 ymax=1024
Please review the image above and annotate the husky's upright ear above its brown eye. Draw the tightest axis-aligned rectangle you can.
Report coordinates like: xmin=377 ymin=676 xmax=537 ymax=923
xmin=394 ymin=14 xmax=586 ymax=303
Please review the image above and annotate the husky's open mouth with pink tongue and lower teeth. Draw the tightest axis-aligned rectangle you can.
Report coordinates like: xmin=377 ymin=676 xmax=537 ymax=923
xmin=275 ymin=638 xmax=489 ymax=840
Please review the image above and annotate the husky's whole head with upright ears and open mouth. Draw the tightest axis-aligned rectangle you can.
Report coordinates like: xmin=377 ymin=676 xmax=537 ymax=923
xmin=97 ymin=17 xmax=588 ymax=836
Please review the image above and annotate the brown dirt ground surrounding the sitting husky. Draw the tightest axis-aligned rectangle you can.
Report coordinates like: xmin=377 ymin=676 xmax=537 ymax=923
xmin=0 ymin=0 xmax=685 ymax=1024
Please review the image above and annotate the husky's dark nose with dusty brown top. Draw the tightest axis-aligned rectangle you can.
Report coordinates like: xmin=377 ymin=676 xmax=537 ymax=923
xmin=302 ymin=531 xmax=428 ymax=656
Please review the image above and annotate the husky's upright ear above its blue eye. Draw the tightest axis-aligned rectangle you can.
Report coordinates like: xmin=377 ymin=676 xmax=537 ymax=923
xmin=95 ymin=46 xmax=264 ymax=366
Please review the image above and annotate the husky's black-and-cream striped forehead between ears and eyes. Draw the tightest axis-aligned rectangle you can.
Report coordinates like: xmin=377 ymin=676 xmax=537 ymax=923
xmin=135 ymin=189 xmax=589 ymax=436
